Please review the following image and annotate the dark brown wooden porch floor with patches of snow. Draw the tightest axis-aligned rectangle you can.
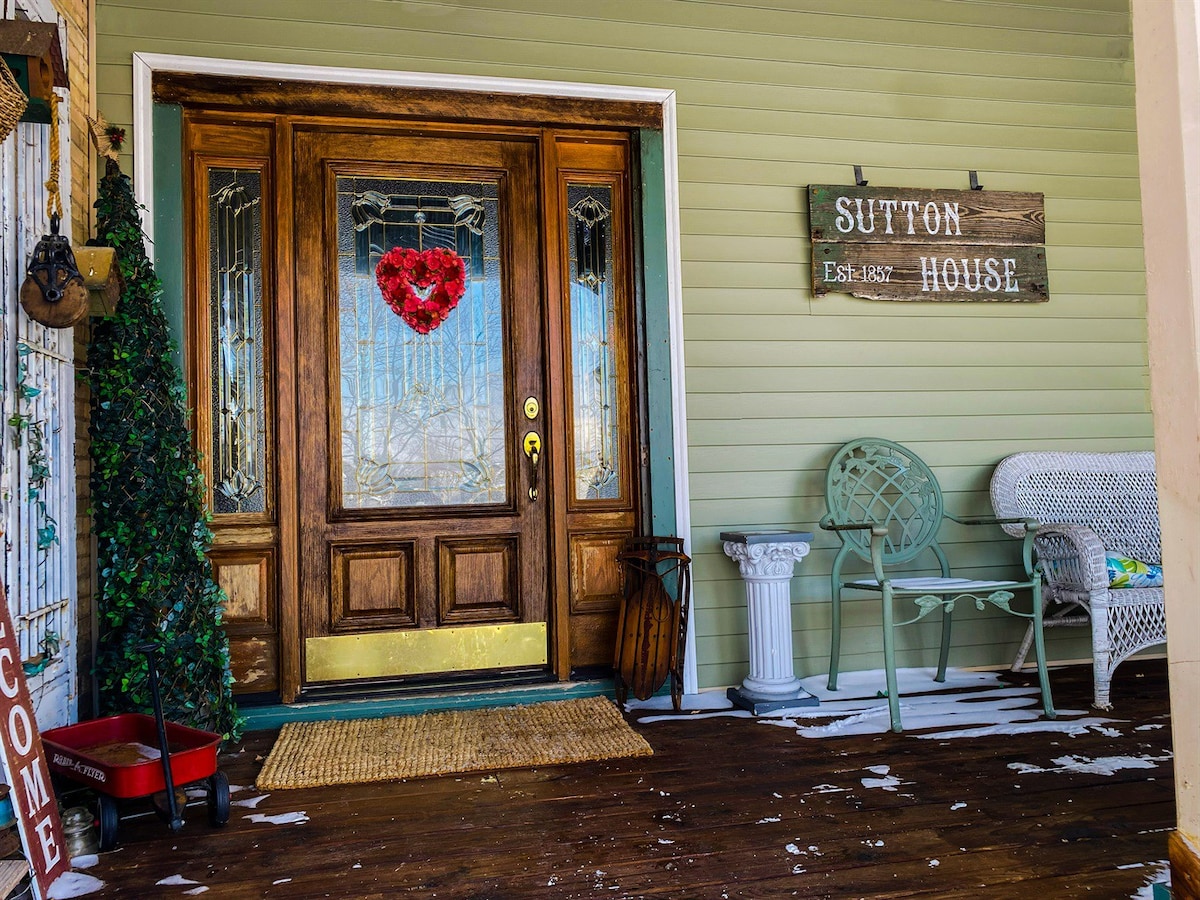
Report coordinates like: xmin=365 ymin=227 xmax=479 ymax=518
xmin=72 ymin=660 xmax=1175 ymax=900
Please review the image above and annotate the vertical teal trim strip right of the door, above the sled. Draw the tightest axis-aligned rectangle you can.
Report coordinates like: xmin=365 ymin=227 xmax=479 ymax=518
xmin=638 ymin=128 xmax=676 ymax=535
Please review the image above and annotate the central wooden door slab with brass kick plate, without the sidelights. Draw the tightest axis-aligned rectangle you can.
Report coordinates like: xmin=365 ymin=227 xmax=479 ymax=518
xmin=294 ymin=127 xmax=556 ymax=685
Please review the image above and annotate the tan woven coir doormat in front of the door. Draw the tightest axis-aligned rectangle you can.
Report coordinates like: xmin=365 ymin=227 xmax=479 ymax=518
xmin=256 ymin=697 xmax=654 ymax=791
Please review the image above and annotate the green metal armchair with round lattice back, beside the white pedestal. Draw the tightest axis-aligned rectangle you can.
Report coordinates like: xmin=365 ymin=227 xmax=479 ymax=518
xmin=821 ymin=438 xmax=1055 ymax=732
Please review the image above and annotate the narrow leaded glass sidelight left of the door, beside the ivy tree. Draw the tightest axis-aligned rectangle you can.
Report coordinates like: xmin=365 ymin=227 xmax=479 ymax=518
xmin=208 ymin=168 xmax=266 ymax=514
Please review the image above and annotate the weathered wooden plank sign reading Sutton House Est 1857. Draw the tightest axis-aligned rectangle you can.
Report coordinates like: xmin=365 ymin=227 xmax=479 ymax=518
xmin=809 ymin=185 xmax=1050 ymax=302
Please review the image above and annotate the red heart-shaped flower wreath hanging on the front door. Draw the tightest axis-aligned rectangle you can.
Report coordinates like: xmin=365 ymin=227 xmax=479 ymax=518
xmin=376 ymin=247 xmax=467 ymax=335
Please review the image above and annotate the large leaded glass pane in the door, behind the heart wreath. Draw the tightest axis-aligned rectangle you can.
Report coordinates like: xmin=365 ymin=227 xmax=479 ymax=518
xmin=337 ymin=176 xmax=508 ymax=509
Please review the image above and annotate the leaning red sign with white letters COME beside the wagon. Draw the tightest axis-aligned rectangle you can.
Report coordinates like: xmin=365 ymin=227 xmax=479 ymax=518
xmin=0 ymin=588 xmax=71 ymax=898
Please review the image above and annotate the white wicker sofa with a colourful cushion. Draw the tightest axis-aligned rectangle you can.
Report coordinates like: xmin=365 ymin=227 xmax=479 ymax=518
xmin=991 ymin=451 xmax=1166 ymax=709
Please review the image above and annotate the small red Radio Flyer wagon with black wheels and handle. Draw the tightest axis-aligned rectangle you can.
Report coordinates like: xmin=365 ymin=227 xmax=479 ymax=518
xmin=42 ymin=648 xmax=229 ymax=851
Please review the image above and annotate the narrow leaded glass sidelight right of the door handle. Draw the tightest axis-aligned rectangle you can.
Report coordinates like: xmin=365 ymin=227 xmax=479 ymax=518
xmin=566 ymin=185 xmax=622 ymax=500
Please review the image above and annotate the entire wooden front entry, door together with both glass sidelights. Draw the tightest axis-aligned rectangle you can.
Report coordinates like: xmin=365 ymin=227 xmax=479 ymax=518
xmin=184 ymin=107 xmax=644 ymax=702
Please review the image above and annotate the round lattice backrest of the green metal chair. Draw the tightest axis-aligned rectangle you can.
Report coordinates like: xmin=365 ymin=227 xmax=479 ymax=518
xmin=826 ymin=438 xmax=943 ymax=565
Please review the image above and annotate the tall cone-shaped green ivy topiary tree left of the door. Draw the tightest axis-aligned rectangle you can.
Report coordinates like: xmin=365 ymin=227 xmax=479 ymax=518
xmin=88 ymin=161 xmax=242 ymax=738
